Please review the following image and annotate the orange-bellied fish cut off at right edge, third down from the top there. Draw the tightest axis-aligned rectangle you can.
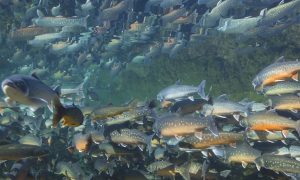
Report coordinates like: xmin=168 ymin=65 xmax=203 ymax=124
xmin=269 ymin=94 xmax=300 ymax=112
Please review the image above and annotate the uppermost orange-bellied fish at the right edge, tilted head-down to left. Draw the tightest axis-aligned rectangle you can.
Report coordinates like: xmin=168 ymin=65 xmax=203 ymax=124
xmin=252 ymin=56 xmax=300 ymax=91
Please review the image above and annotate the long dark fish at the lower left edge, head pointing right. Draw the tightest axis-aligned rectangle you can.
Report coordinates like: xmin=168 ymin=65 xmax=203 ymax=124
xmin=0 ymin=144 xmax=50 ymax=160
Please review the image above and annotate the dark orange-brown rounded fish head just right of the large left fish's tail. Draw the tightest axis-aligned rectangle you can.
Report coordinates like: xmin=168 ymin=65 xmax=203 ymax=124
xmin=62 ymin=105 xmax=84 ymax=127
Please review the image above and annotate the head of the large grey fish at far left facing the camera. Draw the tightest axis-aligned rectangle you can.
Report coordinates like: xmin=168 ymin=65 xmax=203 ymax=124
xmin=1 ymin=75 xmax=29 ymax=99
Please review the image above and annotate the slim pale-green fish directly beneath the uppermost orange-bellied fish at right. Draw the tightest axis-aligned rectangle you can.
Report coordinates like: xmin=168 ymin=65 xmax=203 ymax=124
xmin=263 ymin=81 xmax=300 ymax=96
